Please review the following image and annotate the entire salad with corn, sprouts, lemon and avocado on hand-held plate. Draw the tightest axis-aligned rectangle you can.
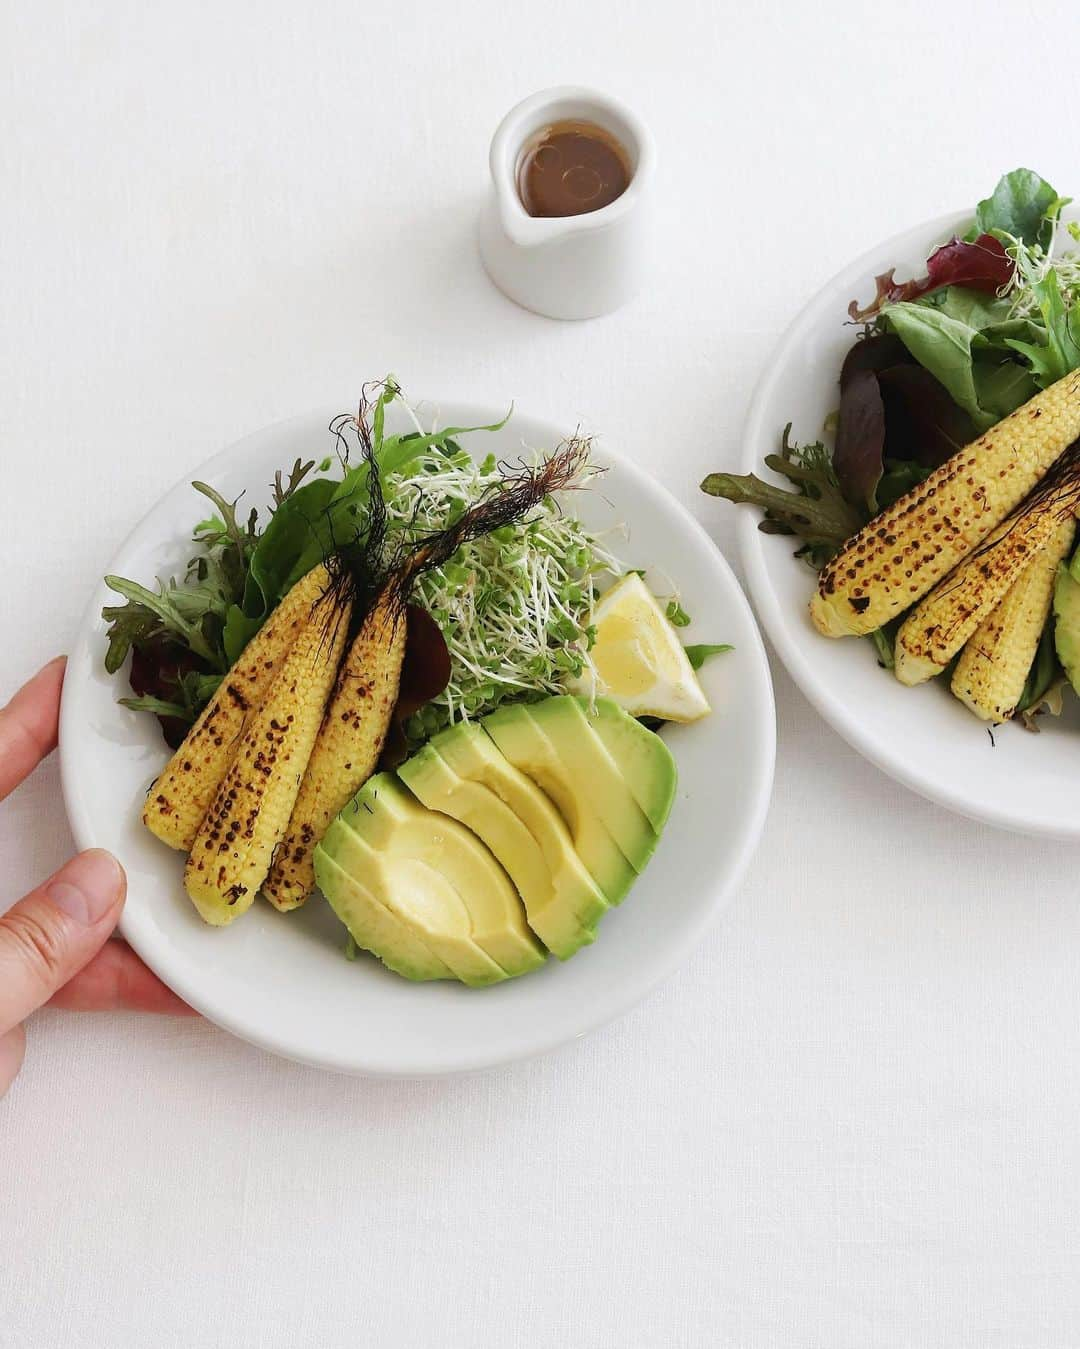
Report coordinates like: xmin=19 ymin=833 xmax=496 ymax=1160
xmin=104 ymin=380 xmax=724 ymax=985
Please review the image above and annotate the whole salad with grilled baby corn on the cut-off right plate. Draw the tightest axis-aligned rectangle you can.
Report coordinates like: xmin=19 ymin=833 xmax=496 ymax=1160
xmin=701 ymin=169 xmax=1080 ymax=726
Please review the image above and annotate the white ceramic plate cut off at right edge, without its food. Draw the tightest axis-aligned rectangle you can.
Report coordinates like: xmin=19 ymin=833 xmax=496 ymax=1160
xmin=739 ymin=212 xmax=1080 ymax=839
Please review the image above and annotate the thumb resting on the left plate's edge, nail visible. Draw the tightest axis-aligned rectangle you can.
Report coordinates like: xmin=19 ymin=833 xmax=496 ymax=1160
xmin=0 ymin=849 xmax=127 ymax=1035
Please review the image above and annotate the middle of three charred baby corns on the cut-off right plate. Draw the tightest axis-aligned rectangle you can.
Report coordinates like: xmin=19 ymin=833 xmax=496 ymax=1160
xmin=895 ymin=445 xmax=1080 ymax=684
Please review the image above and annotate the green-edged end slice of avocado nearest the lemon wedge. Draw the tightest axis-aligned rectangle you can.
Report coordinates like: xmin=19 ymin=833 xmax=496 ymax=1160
xmin=531 ymin=697 xmax=677 ymax=830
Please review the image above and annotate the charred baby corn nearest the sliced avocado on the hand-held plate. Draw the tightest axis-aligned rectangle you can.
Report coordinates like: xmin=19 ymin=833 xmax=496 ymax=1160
xmin=263 ymin=596 xmax=406 ymax=909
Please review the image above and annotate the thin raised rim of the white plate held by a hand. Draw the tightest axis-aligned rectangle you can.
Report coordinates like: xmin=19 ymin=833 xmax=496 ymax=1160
xmin=59 ymin=395 xmax=777 ymax=1079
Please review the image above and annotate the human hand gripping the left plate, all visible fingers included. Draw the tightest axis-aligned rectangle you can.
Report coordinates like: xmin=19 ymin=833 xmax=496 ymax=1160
xmin=0 ymin=657 xmax=191 ymax=1095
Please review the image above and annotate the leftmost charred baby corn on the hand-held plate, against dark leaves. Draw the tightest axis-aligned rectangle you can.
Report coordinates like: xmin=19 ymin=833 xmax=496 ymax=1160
xmin=143 ymin=565 xmax=329 ymax=853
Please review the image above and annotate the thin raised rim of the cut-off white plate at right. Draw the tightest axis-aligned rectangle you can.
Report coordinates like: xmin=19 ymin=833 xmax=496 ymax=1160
xmin=735 ymin=209 xmax=1080 ymax=842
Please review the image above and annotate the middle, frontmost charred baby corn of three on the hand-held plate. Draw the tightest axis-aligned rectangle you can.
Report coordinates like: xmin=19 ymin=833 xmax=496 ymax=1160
xmin=183 ymin=592 xmax=351 ymax=927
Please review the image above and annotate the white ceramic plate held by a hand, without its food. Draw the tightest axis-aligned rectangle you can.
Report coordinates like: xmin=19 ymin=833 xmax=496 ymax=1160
xmin=61 ymin=403 xmax=774 ymax=1075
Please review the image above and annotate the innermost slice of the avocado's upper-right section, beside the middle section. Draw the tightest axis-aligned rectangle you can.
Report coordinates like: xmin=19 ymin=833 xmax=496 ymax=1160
xmin=480 ymin=699 xmax=641 ymax=905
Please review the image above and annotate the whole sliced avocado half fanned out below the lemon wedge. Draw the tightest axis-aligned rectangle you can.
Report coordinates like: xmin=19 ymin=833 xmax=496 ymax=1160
xmin=316 ymin=696 xmax=676 ymax=986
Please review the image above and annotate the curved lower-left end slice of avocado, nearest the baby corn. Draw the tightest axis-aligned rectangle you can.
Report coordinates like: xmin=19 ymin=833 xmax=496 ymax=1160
xmin=314 ymin=820 xmax=454 ymax=981
